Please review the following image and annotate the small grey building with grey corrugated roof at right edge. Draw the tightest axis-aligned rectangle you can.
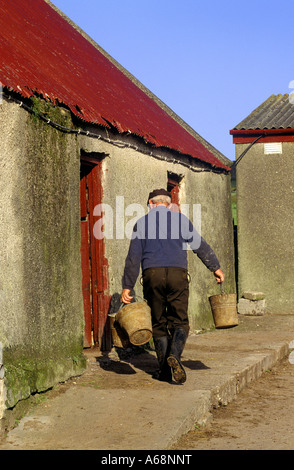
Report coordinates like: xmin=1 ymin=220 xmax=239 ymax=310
xmin=230 ymin=94 xmax=294 ymax=314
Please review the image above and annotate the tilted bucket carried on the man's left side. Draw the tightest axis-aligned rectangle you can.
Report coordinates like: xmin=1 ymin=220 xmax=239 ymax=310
xmin=116 ymin=302 xmax=152 ymax=346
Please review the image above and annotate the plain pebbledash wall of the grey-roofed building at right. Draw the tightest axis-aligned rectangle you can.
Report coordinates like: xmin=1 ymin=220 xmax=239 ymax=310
xmin=236 ymin=141 xmax=294 ymax=314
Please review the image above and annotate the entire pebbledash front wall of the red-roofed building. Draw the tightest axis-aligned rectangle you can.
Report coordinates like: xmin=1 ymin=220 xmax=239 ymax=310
xmin=0 ymin=94 xmax=235 ymax=418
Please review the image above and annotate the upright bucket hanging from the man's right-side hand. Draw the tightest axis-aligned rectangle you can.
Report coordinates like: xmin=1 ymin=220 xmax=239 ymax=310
xmin=209 ymin=291 xmax=238 ymax=328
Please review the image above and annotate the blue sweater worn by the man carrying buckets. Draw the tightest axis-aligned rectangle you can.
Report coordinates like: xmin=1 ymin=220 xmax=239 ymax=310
xmin=122 ymin=206 xmax=220 ymax=289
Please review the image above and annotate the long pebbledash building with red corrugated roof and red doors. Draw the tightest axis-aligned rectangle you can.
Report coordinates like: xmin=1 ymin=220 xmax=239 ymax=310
xmin=0 ymin=0 xmax=235 ymax=417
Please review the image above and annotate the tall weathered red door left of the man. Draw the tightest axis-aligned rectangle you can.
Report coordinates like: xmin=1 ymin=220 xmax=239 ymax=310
xmin=80 ymin=158 xmax=109 ymax=347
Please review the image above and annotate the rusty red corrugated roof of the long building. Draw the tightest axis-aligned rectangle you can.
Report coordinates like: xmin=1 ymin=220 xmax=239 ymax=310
xmin=0 ymin=0 xmax=228 ymax=169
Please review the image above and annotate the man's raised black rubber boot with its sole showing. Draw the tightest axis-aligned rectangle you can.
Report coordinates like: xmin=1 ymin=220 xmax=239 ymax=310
xmin=167 ymin=327 xmax=188 ymax=384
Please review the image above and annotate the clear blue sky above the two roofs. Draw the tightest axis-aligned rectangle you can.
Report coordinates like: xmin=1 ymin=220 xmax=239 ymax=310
xmin=53 ymin=0 xmax=294 ymax=160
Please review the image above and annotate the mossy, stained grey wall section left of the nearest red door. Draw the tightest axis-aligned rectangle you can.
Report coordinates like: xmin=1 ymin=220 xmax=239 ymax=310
xmin=0 ymin=98 xmax=85 ymax=424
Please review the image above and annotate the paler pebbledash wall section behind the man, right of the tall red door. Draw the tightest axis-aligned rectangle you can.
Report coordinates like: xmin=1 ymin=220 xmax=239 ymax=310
xmin=80 ymin=125 xmax=235 ymax=330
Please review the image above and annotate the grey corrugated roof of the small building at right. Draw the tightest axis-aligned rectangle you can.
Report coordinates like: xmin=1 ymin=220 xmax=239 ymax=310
xmin=233 ymin=93 xmax=294 ymax=130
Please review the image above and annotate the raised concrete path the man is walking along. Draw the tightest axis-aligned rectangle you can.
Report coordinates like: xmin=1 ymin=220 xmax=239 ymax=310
xmin=0 ymin=315 xmax=294 ymax=451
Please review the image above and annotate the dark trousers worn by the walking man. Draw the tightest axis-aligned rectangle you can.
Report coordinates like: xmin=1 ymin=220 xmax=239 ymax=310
xmin=143 ymin=267 xmax=189 ymax=338
